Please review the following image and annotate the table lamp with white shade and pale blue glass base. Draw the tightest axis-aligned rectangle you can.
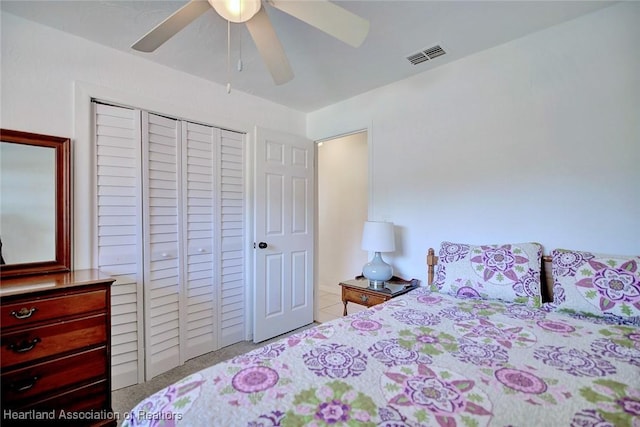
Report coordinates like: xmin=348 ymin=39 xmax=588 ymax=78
xmin=362 ymin=221 xmax=396 ymax=289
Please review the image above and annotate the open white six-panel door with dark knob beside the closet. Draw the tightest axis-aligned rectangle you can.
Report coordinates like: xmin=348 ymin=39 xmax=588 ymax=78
xmin=254 ymin=129 xmax=315 ymax=342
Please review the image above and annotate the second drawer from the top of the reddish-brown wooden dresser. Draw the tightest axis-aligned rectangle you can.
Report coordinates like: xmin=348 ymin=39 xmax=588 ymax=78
xmin=0 ymin=314 xmax=109 ymax=370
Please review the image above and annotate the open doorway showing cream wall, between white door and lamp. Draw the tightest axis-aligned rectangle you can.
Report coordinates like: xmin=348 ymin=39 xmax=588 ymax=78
xmin=314 ymin=131 xmax=369 ymax=322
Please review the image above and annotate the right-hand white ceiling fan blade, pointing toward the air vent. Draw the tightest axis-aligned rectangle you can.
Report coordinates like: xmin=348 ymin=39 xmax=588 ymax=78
xmin=268 ymin=0 xmax=369 ymax=47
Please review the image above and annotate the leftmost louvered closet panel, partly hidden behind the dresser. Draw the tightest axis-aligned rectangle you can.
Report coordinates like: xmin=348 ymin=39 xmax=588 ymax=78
xmin=93 ymin=103 xmax=144 ymax=389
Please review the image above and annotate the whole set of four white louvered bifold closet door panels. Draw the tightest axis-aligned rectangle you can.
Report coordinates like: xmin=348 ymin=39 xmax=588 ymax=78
xmin=94 ymin=103 xmax=247 ymax=389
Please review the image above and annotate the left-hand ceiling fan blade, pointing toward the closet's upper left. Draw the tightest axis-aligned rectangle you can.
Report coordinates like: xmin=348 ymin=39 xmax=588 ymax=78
xmin=131 ymin=0 xmax=211 ymax=52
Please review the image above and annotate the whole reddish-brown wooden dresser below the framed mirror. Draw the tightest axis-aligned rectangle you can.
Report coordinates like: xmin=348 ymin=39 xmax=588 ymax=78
xmin=0 ymin=270 xmax=116 ymax=425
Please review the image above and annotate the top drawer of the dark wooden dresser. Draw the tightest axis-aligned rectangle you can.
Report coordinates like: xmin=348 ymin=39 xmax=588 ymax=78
xmin=0 ymin=289 xmax=108 ymax=329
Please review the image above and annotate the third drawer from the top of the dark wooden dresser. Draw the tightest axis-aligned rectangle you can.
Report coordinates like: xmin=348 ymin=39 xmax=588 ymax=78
xmin=2 ymin=347 xmax=107 ymax=408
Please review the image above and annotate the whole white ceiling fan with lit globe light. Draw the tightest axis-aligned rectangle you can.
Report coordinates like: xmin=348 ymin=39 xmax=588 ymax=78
xmin=131 ymin=0 xmax=369 ymax=85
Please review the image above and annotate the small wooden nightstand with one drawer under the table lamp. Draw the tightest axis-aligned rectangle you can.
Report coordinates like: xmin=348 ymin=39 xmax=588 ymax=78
xmin=340 ymin=276 xmax=420 ymax=316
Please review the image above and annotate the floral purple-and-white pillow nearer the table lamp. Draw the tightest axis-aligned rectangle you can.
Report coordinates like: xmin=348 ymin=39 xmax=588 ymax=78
xmin=431 ymin=242 xmax=542 ymax=307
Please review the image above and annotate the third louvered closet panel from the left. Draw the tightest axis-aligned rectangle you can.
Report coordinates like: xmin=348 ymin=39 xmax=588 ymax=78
xmin=181 ymin=123 xmax=220 ymax=360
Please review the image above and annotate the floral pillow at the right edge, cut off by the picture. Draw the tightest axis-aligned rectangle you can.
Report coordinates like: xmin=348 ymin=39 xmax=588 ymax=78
xmin=551 ymin=249 xmax=640 ymax=320
